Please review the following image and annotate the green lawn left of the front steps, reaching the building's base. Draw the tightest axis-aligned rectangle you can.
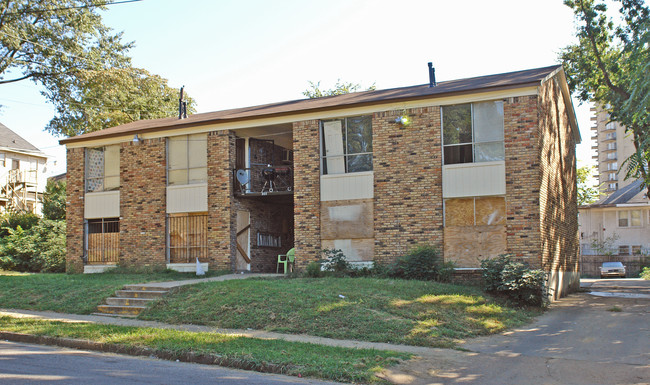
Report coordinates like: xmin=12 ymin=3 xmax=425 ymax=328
xmin=0 ymin=271 xmax=225 ymax=314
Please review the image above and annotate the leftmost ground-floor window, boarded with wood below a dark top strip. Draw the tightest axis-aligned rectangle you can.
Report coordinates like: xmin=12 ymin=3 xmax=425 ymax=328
xmin=86 ymin=218 xmax=120 ymax=265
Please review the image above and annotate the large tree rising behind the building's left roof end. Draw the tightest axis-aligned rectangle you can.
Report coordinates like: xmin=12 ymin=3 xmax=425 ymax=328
xmin=0 ymin=0 xmax=194 ymax=136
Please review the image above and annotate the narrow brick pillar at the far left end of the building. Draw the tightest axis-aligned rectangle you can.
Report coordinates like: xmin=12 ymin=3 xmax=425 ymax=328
xmin=65 ymin=148 xmax=85 ymax=273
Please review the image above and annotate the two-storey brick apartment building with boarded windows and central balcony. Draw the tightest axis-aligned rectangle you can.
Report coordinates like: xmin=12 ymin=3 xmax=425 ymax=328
xmin=61 ymin=66 xmax=580 ymax=297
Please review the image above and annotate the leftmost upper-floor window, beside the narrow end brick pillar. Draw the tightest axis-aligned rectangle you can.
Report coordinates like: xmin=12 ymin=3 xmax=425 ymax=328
xmin=86 ymin=145 xmax=120 ymax=192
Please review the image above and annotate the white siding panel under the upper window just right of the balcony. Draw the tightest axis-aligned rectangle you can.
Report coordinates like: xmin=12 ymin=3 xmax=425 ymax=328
xmin=320 ymin=172 xmax=374 ymax=201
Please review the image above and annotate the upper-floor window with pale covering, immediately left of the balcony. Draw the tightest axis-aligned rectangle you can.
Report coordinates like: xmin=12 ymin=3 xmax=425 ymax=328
xmin=167 ymin=134 xmax=208 ymax=185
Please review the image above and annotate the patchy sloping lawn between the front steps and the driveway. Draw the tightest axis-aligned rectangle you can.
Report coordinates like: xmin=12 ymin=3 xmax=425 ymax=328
xmin=140 ymin=278 xmax=539 ymax=348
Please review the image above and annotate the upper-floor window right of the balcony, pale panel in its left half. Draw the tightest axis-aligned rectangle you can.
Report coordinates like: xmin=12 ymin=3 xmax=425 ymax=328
xmin=321 ymin=116 xmax=372 ymax=175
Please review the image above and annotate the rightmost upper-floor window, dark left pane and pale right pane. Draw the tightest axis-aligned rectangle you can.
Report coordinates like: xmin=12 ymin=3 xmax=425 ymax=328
xmin=442 ymin=101 xmax=505 ymax=164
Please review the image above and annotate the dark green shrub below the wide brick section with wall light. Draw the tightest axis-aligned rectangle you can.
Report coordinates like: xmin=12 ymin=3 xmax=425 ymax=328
xmin=388 ymin=245 xmax=451 ymax=280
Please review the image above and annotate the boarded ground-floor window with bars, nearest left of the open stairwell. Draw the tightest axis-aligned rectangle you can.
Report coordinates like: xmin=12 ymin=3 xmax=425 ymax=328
xmin=167 ymin=213 xmax=208 ymax=263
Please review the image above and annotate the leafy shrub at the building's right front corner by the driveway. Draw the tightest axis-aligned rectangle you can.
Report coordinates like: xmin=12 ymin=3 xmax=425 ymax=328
xmin=481 ymin=255 xmax=548 ymax=306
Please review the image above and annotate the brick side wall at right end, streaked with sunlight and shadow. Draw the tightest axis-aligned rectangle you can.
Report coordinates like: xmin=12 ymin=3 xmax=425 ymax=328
xmin=539 ymin=77 xmax=579 ymax=299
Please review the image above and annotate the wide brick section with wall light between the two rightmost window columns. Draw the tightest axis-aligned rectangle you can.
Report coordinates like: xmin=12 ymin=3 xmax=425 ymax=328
xmin=372 ymin=106 xmax=443 ymax=264
